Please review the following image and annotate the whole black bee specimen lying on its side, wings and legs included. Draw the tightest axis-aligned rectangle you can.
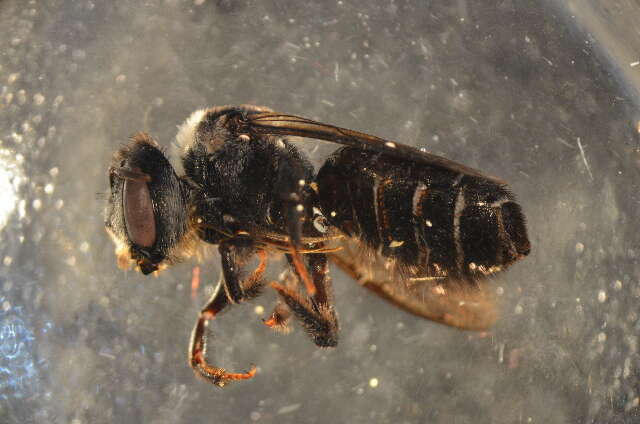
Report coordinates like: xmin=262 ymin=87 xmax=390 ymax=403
xmin=105 ymin=105 xmax=530 ymax=387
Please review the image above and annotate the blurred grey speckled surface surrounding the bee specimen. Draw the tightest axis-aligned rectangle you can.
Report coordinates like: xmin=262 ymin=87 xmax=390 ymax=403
xmin=0 ymin=0 xmax=640 ymax=424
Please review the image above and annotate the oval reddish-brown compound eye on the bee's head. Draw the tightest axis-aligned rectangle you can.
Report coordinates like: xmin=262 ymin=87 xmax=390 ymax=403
xmin=122 ymin=168 xmax=156 ymax=247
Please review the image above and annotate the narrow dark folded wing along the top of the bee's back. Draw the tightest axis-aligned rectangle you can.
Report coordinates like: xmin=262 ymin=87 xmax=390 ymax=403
xmin=236 ymin=112 xmax=505 ymax=184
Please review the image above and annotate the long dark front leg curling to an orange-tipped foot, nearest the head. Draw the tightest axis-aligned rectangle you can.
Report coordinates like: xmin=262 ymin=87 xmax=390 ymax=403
xmin=189 ymin=238 xmax=266 ymax=387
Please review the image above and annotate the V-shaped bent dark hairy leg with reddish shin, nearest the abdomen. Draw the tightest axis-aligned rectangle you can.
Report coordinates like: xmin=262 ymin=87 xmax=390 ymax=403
xmin=271 ymin=254 xmax=338 ymax=347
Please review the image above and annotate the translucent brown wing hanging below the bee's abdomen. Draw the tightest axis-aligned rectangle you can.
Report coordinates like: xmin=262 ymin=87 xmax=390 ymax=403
xmin=329 ymin=239 xmax=498 ymax=330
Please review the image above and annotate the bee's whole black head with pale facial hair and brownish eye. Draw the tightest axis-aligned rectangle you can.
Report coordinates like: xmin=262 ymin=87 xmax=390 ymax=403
xmin=105 ymin=133 xmax=189 ymax=274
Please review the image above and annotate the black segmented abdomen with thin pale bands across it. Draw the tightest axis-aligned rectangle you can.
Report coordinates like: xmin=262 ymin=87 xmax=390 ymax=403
xmin=316 ymin=147 xmax=530 ymax=278
